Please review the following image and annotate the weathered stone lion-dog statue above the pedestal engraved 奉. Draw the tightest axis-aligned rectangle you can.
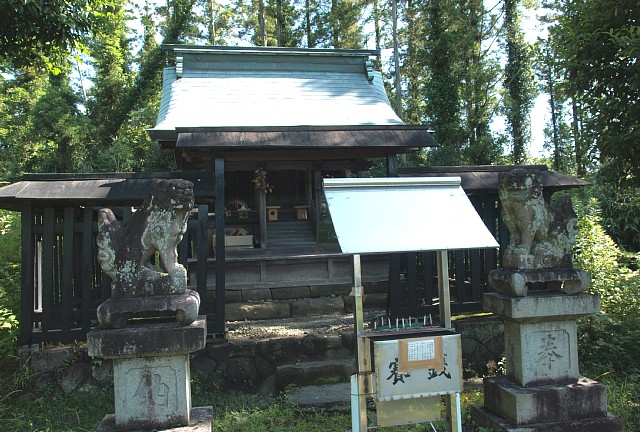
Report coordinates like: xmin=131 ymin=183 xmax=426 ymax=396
xmin=489 ymin=168 xmax=589 ymax=296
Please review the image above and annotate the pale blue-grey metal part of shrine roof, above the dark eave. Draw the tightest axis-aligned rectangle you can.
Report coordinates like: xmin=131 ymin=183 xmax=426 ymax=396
xmin=149 ymin=46 xmax=435 ymax=150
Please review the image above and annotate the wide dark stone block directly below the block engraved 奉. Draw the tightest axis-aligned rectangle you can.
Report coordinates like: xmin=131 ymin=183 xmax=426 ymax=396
xmin=484 ymin=377 xmax=607 ymax=425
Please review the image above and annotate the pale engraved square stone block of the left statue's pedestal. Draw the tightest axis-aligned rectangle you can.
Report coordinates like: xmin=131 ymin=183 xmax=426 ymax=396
xmin=113 ymin=354 xmax=191 ymax=430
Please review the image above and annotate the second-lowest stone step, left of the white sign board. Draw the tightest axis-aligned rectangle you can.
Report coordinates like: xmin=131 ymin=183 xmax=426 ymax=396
xmin=276 ymin=359 xmax=355 ymax=390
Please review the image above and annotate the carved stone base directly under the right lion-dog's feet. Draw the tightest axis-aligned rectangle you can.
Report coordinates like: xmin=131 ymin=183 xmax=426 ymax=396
xmin=489 ymin=269 xmax=591 ymax=297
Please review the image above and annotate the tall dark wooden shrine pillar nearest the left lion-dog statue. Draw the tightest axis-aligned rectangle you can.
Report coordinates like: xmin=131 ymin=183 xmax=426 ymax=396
xmin=214 ymin=155 xmax=225 ymax=337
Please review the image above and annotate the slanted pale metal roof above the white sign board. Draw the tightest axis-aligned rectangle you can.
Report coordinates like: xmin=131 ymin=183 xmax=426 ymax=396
xmin=324 ymin=177 xmax=499 ymax=254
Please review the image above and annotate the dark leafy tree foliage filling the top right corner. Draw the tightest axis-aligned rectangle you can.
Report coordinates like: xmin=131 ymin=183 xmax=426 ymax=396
xmin=550 ymin=0 xmax=640 ymax=188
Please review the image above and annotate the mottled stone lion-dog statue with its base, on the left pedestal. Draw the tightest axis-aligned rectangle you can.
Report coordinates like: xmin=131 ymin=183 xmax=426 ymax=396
xmin=97 ymin=179 xmax=200 ymax=327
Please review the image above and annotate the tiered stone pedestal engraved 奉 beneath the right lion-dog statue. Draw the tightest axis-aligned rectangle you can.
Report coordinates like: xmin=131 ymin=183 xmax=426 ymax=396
xmin=472 ymin=292 xmax=624 ymax=432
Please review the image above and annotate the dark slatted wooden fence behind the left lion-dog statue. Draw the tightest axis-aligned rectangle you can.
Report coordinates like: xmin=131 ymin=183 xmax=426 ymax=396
xmin=18 ymin=205 xmax=224 ymax=346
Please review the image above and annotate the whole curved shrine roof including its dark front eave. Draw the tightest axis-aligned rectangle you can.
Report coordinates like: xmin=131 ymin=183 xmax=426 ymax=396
xmin=149 ymin=45 xmax=437 ymax=149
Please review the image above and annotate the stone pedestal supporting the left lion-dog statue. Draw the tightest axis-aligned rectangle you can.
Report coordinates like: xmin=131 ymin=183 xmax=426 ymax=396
xmin=87 ymin=317 xmax=212 ymax=432
